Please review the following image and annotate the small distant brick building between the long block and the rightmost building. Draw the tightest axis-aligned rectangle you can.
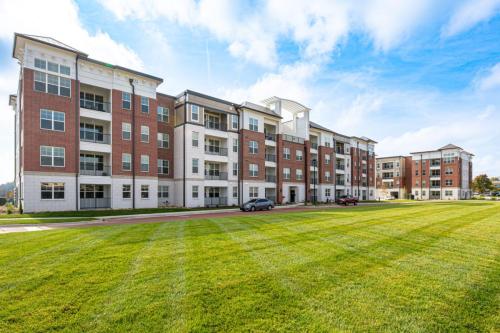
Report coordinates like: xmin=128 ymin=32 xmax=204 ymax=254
xmin=376 ymin=156 xmax=412 ymax=199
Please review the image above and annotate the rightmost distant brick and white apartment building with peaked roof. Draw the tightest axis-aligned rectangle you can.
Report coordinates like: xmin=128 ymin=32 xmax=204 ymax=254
xmin=411 ymin=144 xmax=474 ymax=200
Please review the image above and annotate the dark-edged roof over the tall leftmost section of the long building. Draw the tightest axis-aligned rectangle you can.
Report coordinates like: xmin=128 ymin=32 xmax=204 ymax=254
xmin=12 ymin=32 xmax=163 ymax=83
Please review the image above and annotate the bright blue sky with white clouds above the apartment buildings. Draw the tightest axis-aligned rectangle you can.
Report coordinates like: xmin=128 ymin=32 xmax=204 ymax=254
xmin=0 ymin=0 xmax=500 ymax=183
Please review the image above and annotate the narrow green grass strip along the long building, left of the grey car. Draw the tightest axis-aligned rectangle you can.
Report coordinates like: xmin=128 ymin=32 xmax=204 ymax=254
xmin=0 ymin=207 xmax=234 ymax=219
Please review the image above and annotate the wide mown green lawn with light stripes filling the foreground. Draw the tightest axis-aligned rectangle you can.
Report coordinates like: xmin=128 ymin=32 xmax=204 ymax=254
xmin=0 ymin=202 xmax=500 ymax=333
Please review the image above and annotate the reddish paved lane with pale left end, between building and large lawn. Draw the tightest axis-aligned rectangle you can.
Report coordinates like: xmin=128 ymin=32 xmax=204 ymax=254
xmin=0 ymin=203 xmax=390 ymax=234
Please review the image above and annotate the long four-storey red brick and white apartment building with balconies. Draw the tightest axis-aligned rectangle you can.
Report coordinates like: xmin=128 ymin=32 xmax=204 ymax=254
xmin=9 ymin=34 xmax=376 ymax=212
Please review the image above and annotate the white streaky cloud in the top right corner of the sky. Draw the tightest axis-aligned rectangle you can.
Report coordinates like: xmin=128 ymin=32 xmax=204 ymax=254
xmin=441 ymin=0 xmax=500 ymax=37
